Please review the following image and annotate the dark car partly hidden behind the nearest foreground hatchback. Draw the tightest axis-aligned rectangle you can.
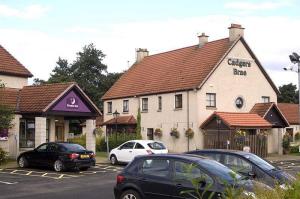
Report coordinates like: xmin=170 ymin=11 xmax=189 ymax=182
xmin=187 ymin=149 xmax=295 ymax=187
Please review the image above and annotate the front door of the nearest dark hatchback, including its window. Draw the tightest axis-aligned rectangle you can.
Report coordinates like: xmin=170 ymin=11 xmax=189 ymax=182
xmin=172 ymin=160 xmax=217 ymax=199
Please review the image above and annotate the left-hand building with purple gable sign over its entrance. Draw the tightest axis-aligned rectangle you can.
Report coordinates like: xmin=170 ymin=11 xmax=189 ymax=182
xmin=0 ymin=46 xmax=101 ymax=157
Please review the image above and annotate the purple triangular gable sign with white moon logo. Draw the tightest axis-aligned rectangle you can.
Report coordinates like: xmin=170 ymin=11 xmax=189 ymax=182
xmin=52 ymin=91 xmax=91 ymax=113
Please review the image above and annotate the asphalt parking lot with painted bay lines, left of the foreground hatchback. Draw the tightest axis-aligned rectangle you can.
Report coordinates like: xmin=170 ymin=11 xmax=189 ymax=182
xmin=0 ymin=164 xmax=122 ymax=199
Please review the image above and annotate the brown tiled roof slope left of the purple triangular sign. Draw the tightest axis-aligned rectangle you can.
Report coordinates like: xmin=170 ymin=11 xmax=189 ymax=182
xmin=20 ymin=82 xmax=75 ymax=112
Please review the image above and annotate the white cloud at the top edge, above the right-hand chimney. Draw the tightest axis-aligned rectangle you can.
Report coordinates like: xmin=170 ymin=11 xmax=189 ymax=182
xmin=224 ymin=1 xmax=290 ymax=11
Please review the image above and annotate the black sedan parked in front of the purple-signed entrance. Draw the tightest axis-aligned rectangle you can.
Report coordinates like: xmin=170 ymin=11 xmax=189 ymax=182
xmin=17 ymin=142 xmax=95 ymax=172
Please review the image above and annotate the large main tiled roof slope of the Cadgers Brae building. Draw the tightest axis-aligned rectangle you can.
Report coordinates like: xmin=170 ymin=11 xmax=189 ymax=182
xmin=102 ymin=38 xmax=231 ymax=99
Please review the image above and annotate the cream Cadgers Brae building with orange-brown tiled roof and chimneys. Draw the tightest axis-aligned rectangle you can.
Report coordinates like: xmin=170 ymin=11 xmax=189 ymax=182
xmin=103 ymin=24 xmax=289 ymax=153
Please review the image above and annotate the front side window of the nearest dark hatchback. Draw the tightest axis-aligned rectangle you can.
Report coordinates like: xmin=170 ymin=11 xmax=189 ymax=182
xmin=174 ymin=161 xmax=213 ymax=184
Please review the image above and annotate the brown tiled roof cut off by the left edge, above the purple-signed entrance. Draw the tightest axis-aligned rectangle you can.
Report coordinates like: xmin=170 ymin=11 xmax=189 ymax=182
xmin=0 ymin=45 xmax=33 ymax=77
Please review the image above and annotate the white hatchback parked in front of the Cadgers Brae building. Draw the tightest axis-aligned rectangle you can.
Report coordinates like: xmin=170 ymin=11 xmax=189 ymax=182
xmin=109 ymin=140 xmax=168 ymax=165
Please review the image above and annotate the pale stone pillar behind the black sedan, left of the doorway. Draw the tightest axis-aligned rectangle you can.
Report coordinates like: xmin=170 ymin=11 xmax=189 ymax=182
xmin=34 ymin=117 xmax=46 ymax=147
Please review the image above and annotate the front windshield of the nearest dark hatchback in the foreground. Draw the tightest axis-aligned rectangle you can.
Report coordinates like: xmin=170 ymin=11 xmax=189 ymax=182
xmin=200 ymin=159 xmax=242 ymax=183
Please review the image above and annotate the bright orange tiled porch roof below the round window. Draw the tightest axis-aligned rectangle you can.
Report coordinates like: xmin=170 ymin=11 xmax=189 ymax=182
xmin=201 ymin=112 xmax=272 ymax=128
